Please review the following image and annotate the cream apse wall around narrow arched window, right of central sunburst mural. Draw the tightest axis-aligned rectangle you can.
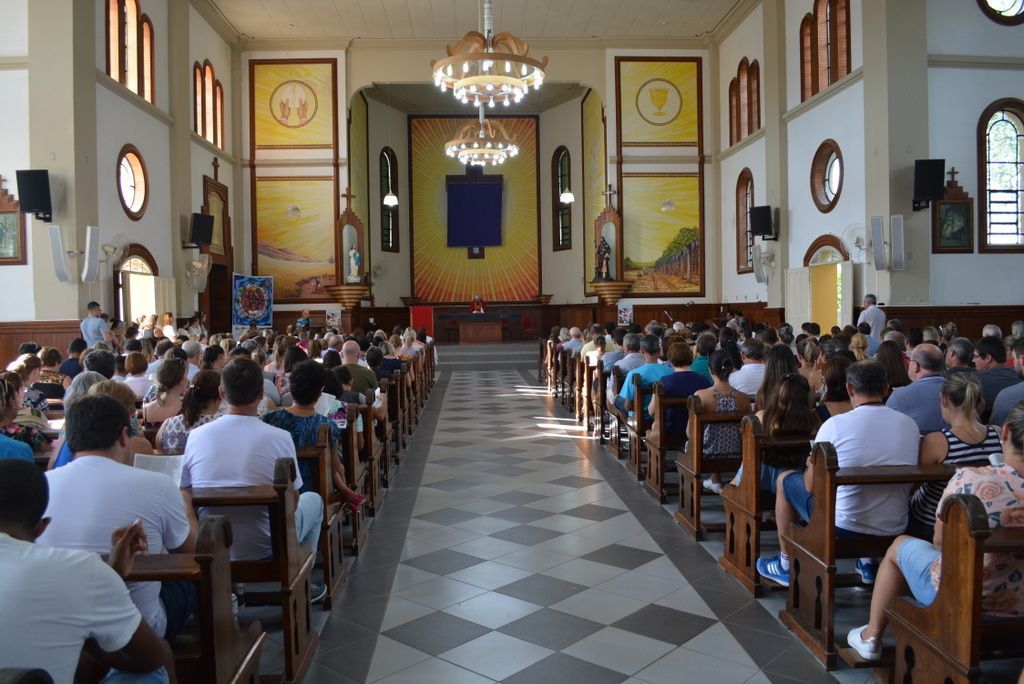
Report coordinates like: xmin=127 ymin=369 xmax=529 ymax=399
xmin=538 ymin=93 xmax=596 ymax=304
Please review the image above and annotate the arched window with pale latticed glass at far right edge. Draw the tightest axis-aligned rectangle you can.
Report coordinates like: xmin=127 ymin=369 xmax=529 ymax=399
xmin=978 ymin=98 xmax=1024 ymax=252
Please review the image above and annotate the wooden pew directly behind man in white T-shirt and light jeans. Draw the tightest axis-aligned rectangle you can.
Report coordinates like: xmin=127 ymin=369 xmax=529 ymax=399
xmin=183 ymin=459 xmax=319 ymax=684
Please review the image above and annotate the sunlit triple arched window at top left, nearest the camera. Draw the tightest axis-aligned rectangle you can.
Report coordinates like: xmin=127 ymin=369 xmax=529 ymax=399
xmin=106 ymin=0 xmax=156 ymax=102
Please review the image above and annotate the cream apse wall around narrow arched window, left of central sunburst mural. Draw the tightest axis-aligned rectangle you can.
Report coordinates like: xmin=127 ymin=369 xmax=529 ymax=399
xmin=366 ymin=98 xmax=413 ymax=306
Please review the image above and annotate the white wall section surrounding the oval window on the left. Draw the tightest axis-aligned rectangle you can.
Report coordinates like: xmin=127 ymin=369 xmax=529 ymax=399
xmin=94 ymin=85 xmax=174 ymax=310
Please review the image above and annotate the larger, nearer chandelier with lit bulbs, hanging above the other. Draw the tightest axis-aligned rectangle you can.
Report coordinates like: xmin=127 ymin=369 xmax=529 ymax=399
xmin=430 ymin=0 xmax=548 ymax=106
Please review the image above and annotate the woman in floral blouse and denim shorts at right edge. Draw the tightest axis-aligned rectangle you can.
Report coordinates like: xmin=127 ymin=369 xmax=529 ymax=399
xmin=847 ymin=403 xmax=1024 ymax=660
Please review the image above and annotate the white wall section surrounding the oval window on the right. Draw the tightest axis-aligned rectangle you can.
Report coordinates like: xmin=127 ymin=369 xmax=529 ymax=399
xmin=782 ymin=82 xmax=866 ymax=270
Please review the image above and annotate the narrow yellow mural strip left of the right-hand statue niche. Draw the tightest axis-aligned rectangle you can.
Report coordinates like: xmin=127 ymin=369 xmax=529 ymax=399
xmin=581 ymin=90 xmax=608 ymax=296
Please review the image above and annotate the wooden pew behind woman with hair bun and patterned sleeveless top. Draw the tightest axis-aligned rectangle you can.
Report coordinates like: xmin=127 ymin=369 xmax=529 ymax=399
xmin=676 ymin=396 xmax=750 ymax=540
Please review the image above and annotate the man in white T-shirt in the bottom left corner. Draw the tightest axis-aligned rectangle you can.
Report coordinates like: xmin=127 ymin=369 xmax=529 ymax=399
xmin=0 ymin=459 xmax=173 ymax=684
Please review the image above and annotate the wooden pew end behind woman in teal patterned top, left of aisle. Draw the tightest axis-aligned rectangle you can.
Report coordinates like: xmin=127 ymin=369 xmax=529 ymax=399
xmin=296 ymin=425 xmax=355 ymax=610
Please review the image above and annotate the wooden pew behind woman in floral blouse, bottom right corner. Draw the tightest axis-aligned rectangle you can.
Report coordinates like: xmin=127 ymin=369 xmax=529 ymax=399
xmin=880 ymin=495 xmax=1024 ymax=684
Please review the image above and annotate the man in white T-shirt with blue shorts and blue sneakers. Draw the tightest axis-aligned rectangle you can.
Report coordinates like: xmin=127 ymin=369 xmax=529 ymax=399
xmin=757 ymin=360 xmax=921 ymax=587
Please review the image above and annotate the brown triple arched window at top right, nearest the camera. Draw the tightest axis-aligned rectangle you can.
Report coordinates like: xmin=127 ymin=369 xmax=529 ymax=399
xmin=800 ymin=0 xmax=850 ymax=101
